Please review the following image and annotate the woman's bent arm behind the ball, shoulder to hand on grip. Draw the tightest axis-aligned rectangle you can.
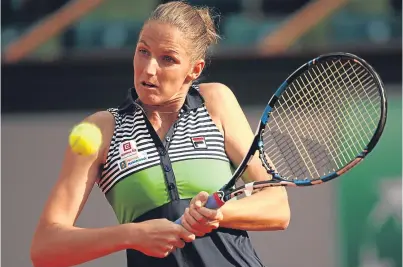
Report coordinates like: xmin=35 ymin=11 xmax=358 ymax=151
xmin=31 ymin=112 xmax=194 ymax=267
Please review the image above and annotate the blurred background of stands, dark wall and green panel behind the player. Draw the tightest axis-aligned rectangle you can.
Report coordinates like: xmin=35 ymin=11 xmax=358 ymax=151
xmin=1 ymin=0 xmax=402 ymax=267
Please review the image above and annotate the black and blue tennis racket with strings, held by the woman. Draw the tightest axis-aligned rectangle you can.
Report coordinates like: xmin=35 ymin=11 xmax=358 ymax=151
xmin=176 ymin=53 xmax=387 ymax=224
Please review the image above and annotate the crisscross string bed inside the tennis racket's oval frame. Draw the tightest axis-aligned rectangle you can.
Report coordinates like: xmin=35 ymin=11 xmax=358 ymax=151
xmin=263 ymin=60 xmax=380 ymax=179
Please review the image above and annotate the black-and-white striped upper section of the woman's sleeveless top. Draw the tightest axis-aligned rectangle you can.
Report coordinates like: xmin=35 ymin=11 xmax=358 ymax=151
xmin=99 ymin=85 xmax=229 ymax=198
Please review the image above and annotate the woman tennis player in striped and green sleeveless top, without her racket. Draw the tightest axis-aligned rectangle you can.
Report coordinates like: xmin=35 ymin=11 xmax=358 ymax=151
xmin=31 ymin=1 xmax=290 ymax=267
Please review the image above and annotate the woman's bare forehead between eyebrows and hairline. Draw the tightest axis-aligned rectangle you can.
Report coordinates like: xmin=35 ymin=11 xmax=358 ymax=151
xmin=139 ymin=21 xmax=187 ymax=52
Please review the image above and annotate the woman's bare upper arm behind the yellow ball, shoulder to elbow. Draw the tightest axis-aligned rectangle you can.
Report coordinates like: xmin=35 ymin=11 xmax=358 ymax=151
xmin=39 ymin=111 xmax=114 ymax=227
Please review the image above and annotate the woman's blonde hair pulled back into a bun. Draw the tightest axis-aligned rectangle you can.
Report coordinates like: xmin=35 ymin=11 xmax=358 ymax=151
xmin=147 ymin=1 xmax=220 ymax=59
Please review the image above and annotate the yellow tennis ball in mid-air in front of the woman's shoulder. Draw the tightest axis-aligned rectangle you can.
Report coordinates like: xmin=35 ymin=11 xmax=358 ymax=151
xmin=69 ymin=122 xmax=102 ymax=156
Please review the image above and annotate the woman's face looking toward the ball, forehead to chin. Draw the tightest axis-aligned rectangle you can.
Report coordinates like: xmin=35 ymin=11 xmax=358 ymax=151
xmin=133 ymin=22 xmax=204 ymax=105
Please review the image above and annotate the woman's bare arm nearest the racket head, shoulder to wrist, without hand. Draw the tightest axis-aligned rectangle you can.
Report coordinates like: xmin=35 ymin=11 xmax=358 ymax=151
xmin=201 ymin=83 xmax=290 ymax=230
